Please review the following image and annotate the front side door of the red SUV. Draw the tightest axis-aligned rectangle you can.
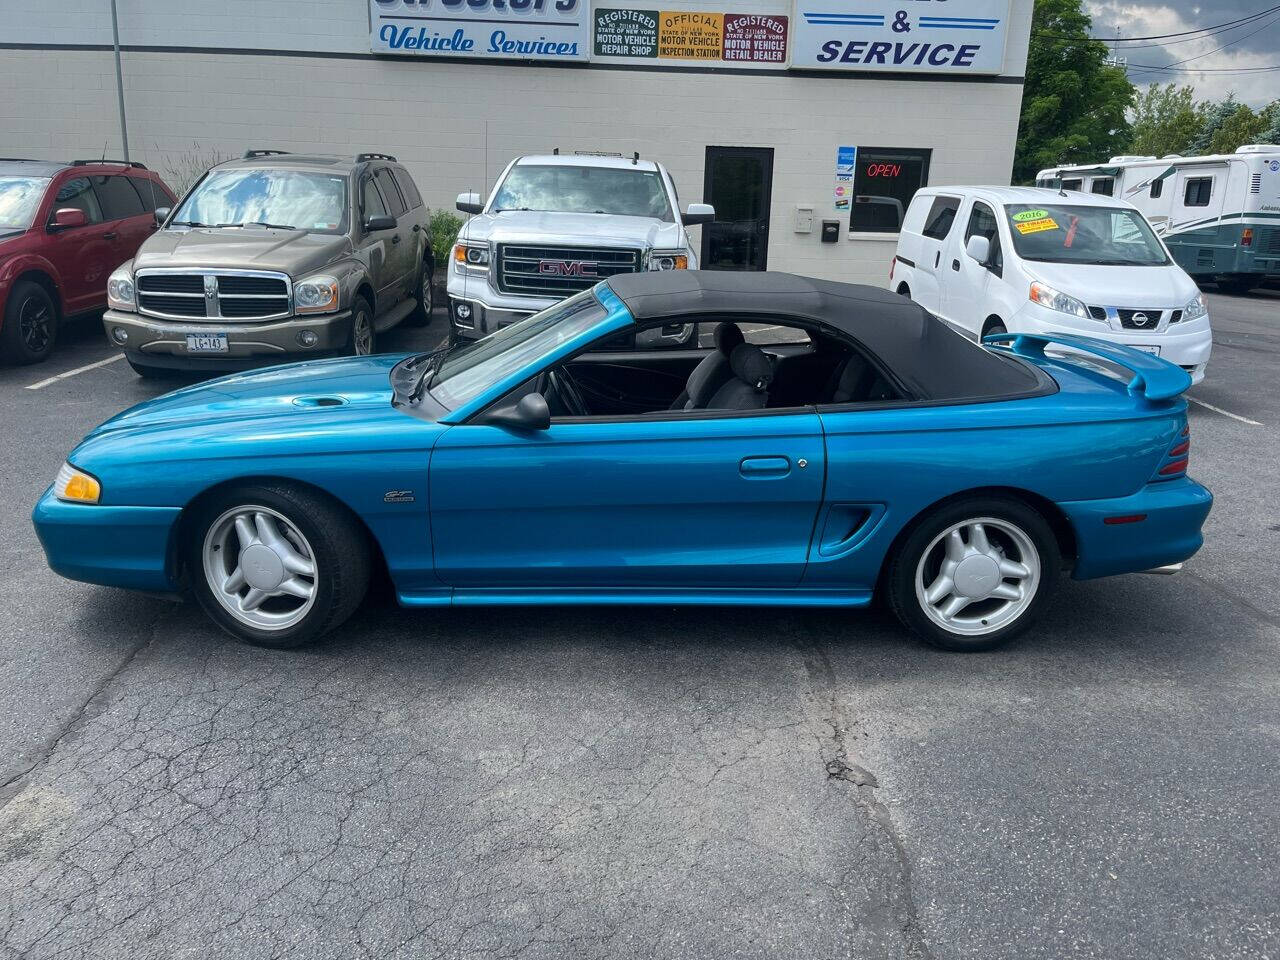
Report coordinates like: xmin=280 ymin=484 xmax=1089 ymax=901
xmin=46 ymin=177 xmax=118 ymax=314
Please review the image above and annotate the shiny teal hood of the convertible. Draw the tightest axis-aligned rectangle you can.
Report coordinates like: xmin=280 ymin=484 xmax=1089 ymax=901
xmin=90 ymin=355 xmax=403 ymax=439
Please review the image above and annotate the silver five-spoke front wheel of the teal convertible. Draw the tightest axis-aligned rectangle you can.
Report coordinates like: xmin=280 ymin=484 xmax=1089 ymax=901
xmin=202 ymin=504 xmax=316 ymax=630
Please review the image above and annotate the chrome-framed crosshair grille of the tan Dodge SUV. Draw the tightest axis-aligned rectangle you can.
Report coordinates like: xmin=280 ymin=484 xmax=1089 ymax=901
xmin=137 ymin=270 xmax=293 ymax=321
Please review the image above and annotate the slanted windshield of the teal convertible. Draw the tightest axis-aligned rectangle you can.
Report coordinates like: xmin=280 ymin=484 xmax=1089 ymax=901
xmin=431 ymin=289 xmax=607 ymax=410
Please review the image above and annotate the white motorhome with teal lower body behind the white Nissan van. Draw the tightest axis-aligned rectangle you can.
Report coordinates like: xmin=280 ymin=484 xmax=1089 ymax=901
xmin=1036 ymin=143 xmax=1280 ymax=293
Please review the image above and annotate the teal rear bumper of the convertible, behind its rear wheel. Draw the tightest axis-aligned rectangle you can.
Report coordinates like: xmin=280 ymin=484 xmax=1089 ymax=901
xmin=1059 ymin=477 xmax=1213 ymax=580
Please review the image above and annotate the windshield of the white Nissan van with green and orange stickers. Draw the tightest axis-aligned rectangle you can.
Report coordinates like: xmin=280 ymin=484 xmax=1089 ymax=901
xmin=1005 ymin=204 xmax=1169 ymax=266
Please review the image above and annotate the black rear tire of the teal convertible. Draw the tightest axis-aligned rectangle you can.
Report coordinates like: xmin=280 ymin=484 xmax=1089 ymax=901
xmin=884 ymin=497 xmax=1062 ymax=653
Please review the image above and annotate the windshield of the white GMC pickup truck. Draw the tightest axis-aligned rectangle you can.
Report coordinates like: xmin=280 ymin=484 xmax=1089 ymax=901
xmin=490 ymin=164 xmax=675 ymax=223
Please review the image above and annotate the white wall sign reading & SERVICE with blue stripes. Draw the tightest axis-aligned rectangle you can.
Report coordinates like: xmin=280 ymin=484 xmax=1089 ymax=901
xmin=791 ymin=0 xmax=1009 ymax=74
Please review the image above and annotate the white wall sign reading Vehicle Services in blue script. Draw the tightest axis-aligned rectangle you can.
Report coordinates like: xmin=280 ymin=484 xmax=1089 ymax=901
xmin=369 ymin=0 xmax=591 ymax=60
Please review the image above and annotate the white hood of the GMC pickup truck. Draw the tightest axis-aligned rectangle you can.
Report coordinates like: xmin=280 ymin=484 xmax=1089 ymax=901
xmin=461 ymin=210 xmax=685 ymax=250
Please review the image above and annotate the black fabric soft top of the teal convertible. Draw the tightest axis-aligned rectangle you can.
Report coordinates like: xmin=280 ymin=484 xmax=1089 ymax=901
xmin=605 ymin=270 xmax=1056 ymax=401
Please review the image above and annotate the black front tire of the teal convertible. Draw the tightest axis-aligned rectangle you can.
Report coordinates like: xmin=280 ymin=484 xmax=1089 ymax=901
xmin=183 ymin=483 xmax=372 ymax=649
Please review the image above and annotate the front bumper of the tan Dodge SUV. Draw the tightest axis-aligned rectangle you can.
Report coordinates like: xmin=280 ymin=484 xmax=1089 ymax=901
xmin=102 ymin=310 xmax=351 ymax=367
